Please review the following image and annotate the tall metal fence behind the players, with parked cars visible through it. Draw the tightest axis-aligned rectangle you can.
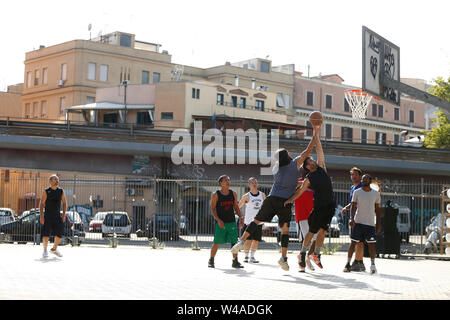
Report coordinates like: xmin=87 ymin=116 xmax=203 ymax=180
xmin=0 ymin=173 xmax=449 ymax=253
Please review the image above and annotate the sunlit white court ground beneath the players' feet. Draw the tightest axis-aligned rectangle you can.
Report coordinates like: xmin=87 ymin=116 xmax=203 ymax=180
xmin=0 ymin=244 xmax=450 ymax=300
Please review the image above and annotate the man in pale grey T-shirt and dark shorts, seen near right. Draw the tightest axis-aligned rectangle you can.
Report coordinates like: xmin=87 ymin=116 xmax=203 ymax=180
xmin=350 ymin=174 xmax=381 ymax=274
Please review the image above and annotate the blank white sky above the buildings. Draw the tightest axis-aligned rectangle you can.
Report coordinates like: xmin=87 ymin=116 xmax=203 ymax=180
xmin=0 ymin=0 xmax=450 ymax=91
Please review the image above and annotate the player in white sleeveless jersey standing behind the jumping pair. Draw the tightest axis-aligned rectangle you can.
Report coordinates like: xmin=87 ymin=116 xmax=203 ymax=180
xmin=239 ymin=177 xmax=266 ymax=263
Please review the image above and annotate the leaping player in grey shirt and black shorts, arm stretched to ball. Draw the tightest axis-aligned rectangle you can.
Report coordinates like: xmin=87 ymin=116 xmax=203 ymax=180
xmin=231 ymin=125 xmax=320 ymax=271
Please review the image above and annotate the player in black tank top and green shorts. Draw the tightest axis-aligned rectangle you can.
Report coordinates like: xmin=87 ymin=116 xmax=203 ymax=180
xmin=208 ymin=175 xmax=244 ymax=268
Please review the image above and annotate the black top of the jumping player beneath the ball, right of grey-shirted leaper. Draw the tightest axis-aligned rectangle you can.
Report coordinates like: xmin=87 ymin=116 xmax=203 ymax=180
xmin=306 ymin=167 xmax=334 ymax=208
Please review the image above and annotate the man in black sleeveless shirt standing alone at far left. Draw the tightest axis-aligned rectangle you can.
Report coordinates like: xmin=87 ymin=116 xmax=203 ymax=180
xmin=39 ymin=175 xmax=67 ymax=258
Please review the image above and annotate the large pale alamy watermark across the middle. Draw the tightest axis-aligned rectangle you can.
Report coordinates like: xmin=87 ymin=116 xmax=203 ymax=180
xmin=171 ymin=121 xmax=279 ymax=175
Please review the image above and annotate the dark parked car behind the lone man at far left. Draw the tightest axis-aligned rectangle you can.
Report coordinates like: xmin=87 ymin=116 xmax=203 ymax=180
xmin=0 ymin=210 xmax=85 ymax=243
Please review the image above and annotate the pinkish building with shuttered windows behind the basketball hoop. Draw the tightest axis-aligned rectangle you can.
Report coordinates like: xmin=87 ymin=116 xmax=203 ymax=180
xmin=294 ymin=74 xmax=425 ymax=145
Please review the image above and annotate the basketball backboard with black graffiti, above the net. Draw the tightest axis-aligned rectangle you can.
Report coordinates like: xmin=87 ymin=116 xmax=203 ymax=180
xmin=362 ymin=26 xmax=400 ymax=105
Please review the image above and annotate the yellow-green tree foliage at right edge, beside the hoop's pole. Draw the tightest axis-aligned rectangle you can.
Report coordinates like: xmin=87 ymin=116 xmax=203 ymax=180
xmin=423 ymin=77 xmax=450 ymax=149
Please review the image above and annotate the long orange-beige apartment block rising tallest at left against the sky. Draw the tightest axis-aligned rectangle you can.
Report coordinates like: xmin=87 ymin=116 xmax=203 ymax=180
xmin=22 ymin=32 xmax=293 ymax=120
